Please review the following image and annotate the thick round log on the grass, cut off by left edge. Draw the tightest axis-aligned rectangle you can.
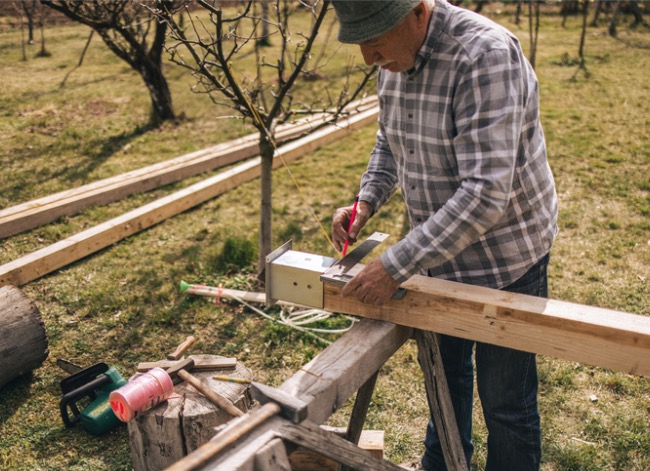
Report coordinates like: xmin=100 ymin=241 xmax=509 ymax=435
xmin=0 ymin=285 xmax=49 ymax=388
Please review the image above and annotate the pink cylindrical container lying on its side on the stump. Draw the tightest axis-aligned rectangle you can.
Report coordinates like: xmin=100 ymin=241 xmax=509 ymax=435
xmin=108 ymin=368 xmax=174 ymax=422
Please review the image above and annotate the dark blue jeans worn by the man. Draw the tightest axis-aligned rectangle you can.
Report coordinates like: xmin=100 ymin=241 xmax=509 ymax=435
xmin=422 ymin=255 xmax=549 ymax=471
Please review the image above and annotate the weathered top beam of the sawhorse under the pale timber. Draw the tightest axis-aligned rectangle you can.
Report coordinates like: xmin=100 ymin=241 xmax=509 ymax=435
xmin=187 ymin=319 xmax=412 ymax=471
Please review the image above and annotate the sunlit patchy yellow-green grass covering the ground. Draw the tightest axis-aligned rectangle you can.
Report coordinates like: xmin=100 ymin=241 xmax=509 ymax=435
xmin=0 ymin=4 xmax=650 ymax=471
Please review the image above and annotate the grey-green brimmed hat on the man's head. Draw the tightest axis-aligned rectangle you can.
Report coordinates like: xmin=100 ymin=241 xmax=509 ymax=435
xmin=332 ymin=0 xmax=422 ymax=44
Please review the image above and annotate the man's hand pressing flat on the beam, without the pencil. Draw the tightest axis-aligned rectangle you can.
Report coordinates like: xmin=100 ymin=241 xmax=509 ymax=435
xmin=341 ymin=258 xmax=399 ymax=305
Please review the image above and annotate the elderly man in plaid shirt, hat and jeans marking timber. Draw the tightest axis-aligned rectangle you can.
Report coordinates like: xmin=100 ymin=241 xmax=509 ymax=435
xmin=332 ymin=0 xmax=557 ymax=471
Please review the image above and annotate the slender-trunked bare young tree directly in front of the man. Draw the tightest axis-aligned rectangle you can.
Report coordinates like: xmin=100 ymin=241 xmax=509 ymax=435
xmin=154 ymin=0 xmax=372 ymax=278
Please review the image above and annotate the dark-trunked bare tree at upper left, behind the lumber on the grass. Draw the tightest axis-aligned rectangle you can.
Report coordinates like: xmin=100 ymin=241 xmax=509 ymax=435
xmin=41 ymin=0 xmax=176 ymax=124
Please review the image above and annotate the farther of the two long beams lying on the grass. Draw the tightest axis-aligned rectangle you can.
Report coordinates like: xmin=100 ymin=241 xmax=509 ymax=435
xmin=0 ymin=99 xmax=376 ymax=238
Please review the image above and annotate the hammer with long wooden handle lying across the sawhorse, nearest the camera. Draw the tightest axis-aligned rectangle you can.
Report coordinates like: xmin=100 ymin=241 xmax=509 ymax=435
xmin=167 ymin=382 xmax=308 ymax=471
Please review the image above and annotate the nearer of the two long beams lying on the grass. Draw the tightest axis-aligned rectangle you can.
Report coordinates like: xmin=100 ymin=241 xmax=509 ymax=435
xmin=0 ymin=108 xmax=377 ymax=286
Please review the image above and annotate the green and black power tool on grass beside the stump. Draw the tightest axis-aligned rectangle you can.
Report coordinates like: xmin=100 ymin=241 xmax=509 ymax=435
xmin=56 ymin=359 xmax=127 ymax=435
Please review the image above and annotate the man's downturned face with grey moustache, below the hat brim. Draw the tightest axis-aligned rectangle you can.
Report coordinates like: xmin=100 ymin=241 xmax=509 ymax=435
xmin=359 ymin=5 xmax=428 ymax=72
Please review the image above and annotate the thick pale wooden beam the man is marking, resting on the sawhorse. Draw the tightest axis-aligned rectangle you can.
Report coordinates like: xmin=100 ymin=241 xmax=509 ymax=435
xmin=322 ymin=276 xmax=650 ymax=376
